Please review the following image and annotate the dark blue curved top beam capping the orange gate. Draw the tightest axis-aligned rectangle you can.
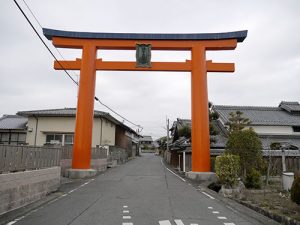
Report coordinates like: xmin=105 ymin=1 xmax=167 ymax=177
xmin=43 ymin=28 xmax=248 ymax=42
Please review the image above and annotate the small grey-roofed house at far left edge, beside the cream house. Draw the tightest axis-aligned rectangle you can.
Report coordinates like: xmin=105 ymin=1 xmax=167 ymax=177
xmin=0 ymin=115 xmax=27 ymax=145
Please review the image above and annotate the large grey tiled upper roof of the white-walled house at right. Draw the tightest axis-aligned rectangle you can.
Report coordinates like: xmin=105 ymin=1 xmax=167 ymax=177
xmin=213 ymin=105 xmax=300 ymax=126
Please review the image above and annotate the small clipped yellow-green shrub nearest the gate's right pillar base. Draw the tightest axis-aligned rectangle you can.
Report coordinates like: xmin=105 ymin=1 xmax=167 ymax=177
xmin=215 ymin=154 xmax=240 ymax=187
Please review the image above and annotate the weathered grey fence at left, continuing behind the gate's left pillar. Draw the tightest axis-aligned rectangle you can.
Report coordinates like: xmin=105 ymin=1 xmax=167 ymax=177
xmin=0 ymin=145 xmax=107 ymax=174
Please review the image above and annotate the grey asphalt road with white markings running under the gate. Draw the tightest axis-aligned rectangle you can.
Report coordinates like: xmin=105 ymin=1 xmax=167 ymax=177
xmin=8 ymin=154 xmax=277 ymax=225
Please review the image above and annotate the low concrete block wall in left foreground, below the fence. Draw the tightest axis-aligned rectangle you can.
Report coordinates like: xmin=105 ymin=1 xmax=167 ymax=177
xmin=0 ymin=166 xmax=60 ymax=215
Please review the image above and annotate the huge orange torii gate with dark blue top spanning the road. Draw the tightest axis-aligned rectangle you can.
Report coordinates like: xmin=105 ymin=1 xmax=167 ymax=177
xmin=43 ymin=28 xmax=247 ymax=178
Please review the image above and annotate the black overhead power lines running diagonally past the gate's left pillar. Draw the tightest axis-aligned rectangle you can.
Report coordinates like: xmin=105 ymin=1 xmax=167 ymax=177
xmin=14 ymin=0 xmax=142 ymax=128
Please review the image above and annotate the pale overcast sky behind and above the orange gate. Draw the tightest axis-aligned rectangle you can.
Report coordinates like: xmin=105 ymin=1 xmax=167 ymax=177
xmin=0 ymin=0 xmax=300 ymax=138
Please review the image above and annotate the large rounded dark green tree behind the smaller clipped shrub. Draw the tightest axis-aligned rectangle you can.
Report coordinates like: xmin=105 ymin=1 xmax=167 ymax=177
xmin=225 ymin=128 xmax=262 ymax=178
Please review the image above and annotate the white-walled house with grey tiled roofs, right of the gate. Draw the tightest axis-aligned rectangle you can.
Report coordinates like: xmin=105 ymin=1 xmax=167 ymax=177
xmin=212 ymin=101 xmax=300 ymax=150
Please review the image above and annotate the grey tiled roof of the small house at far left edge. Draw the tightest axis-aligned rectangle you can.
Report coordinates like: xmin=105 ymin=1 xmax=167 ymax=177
xmin=0 ymin=115 xmax=28 ymax=130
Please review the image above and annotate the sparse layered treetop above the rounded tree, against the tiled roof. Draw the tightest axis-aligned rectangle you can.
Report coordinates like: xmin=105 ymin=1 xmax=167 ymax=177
xmin=225 ymin=111 xmax=250 ymax=133
